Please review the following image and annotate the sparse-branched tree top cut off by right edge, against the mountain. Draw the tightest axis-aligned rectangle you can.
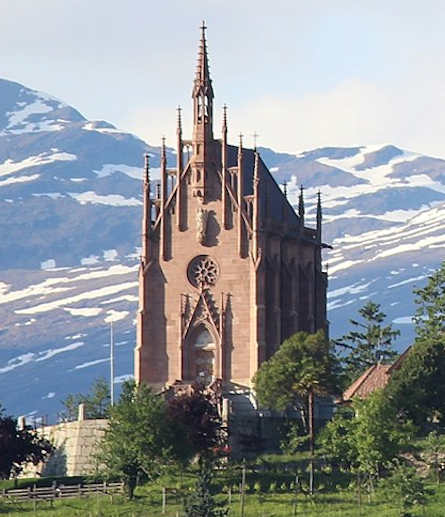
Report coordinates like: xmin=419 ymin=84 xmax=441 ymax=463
xmin=414 ymin=261 xmax=445 ymax=344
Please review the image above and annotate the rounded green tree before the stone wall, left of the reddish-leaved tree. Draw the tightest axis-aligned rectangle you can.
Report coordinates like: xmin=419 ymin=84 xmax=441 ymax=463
xmin=97 ymin=381 xmax=175 ymax=499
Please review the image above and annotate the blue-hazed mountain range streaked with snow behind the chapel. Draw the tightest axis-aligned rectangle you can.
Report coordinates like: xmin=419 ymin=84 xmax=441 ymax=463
xmin=0 ymin=80 xmax=445 ymax=419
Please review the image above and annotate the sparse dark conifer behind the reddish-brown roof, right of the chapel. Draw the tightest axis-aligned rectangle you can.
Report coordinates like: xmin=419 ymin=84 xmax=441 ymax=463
xmin=335 ymin=301 xmax=400 ymax=385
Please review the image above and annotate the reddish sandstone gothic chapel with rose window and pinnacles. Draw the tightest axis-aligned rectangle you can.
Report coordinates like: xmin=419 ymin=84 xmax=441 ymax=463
xmin=135 ymin=24 xmax=327 ymax=392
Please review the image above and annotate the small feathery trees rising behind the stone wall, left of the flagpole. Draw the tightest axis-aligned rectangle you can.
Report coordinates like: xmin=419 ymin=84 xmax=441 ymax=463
xmin=59 ymin=377 xmax=111 ymax=422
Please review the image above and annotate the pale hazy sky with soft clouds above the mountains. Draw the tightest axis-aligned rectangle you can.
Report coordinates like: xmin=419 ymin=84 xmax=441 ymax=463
xmin=0 ymin=0 xmax=445 ymax=157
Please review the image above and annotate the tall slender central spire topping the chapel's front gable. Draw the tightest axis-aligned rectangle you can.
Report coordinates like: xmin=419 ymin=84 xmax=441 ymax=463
xmin=192 ymin=21 xmax=214 ymax=143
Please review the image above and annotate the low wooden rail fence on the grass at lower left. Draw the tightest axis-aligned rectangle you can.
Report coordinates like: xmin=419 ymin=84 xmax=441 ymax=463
xmin=0 ymin=481 xmax=123 ymax=501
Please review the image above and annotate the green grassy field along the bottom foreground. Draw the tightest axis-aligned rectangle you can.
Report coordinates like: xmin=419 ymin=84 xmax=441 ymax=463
xmin=0 ymin=482 xmax=445 ymax=517
